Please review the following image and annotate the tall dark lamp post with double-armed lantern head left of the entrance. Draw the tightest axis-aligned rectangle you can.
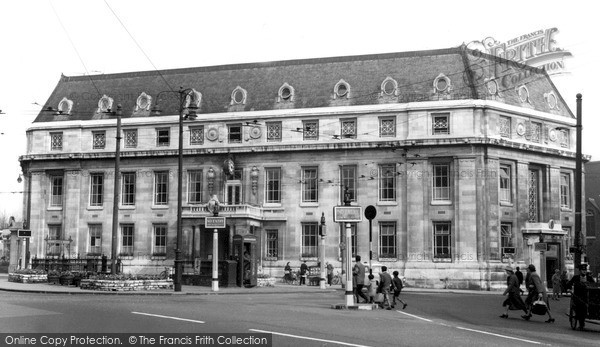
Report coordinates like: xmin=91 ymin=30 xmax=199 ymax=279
xmin=152 ymin=87 xmax=197 ymax=292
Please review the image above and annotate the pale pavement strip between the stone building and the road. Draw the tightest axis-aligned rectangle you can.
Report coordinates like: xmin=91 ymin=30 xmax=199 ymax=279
xmin=0 ymin=273 xmax=502 ymax=296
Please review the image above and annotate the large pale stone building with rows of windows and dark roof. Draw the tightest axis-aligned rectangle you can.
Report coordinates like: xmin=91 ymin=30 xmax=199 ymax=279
xmin=20 ymin=46 xmax=576 ymax=290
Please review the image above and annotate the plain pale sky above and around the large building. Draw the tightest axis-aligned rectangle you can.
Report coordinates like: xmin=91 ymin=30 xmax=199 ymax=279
xmin=0 ymin=0 xmax=600 ymax=218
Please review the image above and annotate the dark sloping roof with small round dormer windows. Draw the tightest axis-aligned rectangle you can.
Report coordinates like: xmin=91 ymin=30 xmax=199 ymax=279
xmin=35 ymin=46 xmax=574 ymax=122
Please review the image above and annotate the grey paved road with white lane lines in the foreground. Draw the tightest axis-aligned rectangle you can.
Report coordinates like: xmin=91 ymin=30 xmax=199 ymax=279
xmin=0 ymin=291 xmax=600 ymax=346
